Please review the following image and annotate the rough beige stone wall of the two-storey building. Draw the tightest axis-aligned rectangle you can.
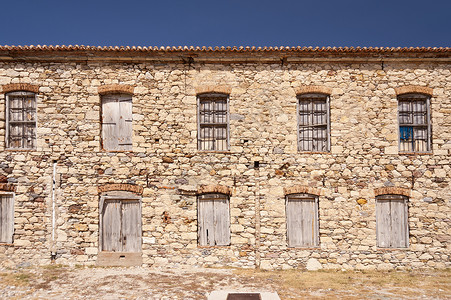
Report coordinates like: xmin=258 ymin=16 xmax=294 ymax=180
xmin=0 ymin=56 xmax=451 ymax=269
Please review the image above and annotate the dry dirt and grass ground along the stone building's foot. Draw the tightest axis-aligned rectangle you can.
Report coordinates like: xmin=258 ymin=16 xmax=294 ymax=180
xmin=0 ymin=265 xmax=451 ymax=299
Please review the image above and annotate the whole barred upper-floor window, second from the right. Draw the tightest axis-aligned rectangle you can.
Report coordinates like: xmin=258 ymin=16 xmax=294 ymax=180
xmin=298 ymin=94 xmax=330 ymax=152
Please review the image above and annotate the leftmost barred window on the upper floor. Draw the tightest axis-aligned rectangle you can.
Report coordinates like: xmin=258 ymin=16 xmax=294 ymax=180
xmin=6 ymin=92 xmax=36 ymax=149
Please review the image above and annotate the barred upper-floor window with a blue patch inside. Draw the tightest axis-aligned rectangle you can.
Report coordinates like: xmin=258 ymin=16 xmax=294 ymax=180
xmin=398 ymin=94 xmax=431 ymax=152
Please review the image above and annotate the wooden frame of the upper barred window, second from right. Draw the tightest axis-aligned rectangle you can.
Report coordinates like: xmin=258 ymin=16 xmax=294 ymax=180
xmin=296 ymin=93 xmax=331 ymax=152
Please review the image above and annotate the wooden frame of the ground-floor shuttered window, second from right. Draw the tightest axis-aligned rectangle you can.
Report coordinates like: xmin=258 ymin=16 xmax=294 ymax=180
xmin=285 ymin=193 xmax=319 ymax=248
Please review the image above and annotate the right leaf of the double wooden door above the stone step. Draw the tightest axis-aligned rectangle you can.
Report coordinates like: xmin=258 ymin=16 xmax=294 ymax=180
xmin=122 ymin=200 xmax=141 ymax=252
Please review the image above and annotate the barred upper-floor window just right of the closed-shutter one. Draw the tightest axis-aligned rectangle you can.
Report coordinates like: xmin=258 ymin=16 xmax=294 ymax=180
xmin=197 ymin=94 xmax=229 ymax=151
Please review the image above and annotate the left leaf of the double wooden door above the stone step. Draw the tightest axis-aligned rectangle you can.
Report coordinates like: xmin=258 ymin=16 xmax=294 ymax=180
xmin=102 ymin=200 xmax=122 ymax=251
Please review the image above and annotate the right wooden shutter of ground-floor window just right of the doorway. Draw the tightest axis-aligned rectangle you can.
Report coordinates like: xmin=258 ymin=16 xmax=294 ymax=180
xmin=213 ymin=197 xmax=230 ymax=246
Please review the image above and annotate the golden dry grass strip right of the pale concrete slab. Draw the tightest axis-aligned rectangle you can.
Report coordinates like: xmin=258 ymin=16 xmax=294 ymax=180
xmin=234 ymin=270 xmax=451 ymax=299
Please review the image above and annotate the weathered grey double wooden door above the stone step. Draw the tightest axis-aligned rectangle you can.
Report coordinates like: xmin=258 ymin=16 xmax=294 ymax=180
xmin=100 ymin=198 xmax=142 ymax=252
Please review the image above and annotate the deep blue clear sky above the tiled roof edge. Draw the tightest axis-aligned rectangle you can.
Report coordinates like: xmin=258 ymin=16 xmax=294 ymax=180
xmin=0 ymin=0 xmax=451 ymax=47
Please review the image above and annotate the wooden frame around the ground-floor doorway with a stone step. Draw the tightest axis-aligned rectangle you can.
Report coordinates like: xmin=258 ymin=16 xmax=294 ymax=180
xmin=99 ymin=191 xmax=143 ymax=253
